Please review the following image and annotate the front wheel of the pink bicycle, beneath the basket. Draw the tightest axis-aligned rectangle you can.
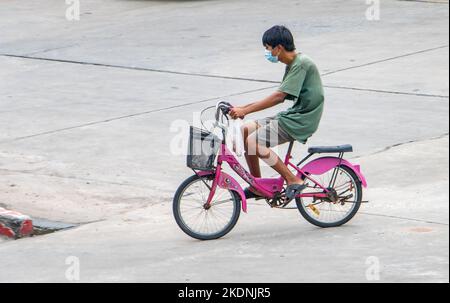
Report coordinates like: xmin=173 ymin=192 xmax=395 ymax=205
xmin=173 ymin=175 xmax=241 ymax=240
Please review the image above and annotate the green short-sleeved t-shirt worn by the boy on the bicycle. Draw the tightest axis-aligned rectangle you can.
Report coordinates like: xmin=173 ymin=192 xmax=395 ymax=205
xmin=277 ymin=53 xmax=325 ymax=143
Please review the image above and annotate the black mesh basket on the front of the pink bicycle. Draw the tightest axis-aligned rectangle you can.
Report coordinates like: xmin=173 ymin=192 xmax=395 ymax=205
xmin=187 ymin=126 xmax=221 ymax=170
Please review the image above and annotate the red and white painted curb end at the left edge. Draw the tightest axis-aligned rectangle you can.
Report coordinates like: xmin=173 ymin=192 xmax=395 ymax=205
xmin=0 ymin=207 xmax=33 ymax=239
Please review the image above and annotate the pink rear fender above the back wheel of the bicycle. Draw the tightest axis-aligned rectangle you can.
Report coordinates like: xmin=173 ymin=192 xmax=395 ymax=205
xmin=301 ymin=157 xmax=367 ymax=187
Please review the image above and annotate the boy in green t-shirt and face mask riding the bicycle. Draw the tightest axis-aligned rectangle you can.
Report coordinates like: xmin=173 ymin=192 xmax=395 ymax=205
xmin=230 ymin=25 xmax=324 ymax=202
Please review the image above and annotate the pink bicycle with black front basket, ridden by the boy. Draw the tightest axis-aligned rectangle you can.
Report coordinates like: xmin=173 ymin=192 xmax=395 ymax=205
xmin=173 ymin=102 xmax=367 ymax=240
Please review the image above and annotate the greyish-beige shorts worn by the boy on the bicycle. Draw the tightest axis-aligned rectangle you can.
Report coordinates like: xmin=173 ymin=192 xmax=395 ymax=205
xmin=255 ymin=116 xmax=295 ymax=147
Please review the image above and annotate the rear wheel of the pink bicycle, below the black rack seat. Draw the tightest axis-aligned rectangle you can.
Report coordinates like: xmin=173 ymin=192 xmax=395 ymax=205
xmin=295 ymin=166 xmax=362 ymax=228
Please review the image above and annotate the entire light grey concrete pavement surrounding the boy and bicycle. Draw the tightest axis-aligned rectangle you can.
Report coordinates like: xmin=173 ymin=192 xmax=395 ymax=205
xmin=0 ymin=0 xmax=449 ymax=282
